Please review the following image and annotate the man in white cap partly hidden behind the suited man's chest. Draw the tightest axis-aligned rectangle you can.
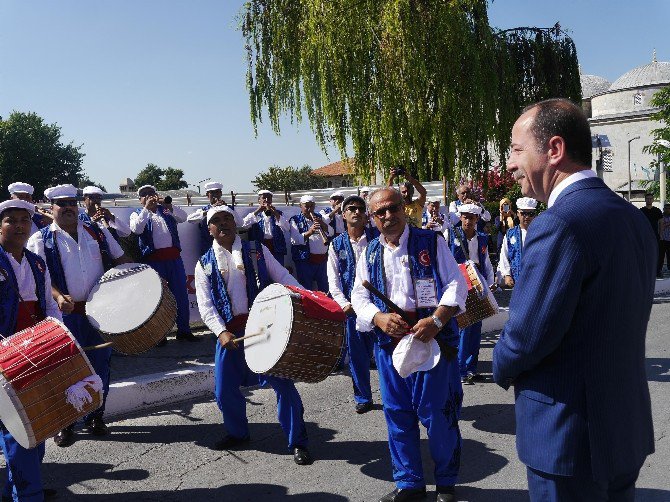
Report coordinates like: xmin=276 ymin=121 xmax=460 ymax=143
xmin=498 ymin=197 xmax=537 ymax=288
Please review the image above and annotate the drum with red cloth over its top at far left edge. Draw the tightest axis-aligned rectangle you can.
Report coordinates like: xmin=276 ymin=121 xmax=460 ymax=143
xmin=0 ymin=317 xmax=102 ymax=448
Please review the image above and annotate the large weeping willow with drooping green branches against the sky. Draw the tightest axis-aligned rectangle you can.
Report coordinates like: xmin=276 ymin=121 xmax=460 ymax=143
xmin=241 ymin=0 xmax=581 ymax=184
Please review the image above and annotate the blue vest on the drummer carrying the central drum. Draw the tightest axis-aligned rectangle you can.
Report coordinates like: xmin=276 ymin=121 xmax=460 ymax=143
xmin=200 ymin=241 xmax=272 ymax=326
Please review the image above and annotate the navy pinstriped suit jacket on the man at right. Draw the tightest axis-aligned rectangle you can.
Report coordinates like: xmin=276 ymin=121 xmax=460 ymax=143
xmin=493 ymin=178 xmax=656 ymax=480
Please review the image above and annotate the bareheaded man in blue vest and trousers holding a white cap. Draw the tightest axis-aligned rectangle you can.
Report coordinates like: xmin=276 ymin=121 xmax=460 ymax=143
xmin=351 ymin=187 xmax=467 ymax=502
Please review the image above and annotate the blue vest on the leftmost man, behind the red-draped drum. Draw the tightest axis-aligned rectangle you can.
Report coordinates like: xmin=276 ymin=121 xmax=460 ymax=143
xmin=0 ymin=249 xmax=51 ymax=336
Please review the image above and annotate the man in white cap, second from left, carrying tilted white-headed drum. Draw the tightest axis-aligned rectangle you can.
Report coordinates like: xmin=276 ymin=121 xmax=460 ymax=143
xmin=27 ymin=185 xmax=130 ymax=447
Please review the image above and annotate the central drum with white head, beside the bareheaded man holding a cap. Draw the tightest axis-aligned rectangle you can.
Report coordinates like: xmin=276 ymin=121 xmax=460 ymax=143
xmin=244 ymin=284 xmax=344 ymax=383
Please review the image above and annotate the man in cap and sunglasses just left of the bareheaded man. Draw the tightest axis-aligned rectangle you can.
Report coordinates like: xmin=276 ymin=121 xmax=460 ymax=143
xmin=327 ymin=195 xmax=379 ymax=414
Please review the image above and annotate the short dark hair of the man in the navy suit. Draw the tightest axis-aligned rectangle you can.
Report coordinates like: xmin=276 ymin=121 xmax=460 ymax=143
xmin=523 ymin=98 xmax=593 ymax=169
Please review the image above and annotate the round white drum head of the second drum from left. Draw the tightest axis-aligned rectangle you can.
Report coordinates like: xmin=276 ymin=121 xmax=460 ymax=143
xmin=86 ymin=263 xmax=163 ymax=334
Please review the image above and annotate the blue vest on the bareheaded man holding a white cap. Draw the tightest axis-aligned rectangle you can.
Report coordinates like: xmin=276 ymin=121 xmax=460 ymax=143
xmin=365 ymin=226 xmax=458 ymax=347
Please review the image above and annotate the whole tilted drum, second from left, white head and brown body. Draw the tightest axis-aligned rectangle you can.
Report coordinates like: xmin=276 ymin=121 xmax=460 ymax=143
xmin=86 ymin=263 xmax=177 ymax=354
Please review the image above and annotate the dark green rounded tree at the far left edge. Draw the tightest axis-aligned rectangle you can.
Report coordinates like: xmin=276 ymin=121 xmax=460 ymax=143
xmin=0 ymin=112 xmax=84 ymax=199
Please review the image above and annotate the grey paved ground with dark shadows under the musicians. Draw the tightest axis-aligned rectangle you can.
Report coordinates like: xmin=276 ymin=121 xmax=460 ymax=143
xmin=5 ymin=296 xmax=670 ymax=502
